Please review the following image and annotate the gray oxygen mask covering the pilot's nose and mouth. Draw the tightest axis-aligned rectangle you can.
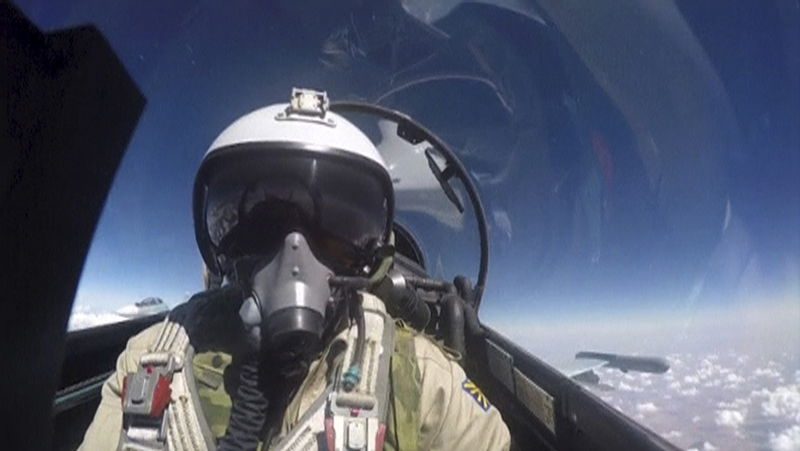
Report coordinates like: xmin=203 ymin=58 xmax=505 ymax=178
xmin=239 ymin=232 xmax=333 ymax=359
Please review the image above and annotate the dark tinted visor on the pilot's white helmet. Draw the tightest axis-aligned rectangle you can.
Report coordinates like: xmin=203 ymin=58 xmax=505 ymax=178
xmin=203 ymin=150 xmax=392 ymax=270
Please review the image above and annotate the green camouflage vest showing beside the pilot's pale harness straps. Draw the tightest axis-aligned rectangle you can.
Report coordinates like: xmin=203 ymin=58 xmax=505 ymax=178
xmin=192 ymin=324 xmax=422 ymax=451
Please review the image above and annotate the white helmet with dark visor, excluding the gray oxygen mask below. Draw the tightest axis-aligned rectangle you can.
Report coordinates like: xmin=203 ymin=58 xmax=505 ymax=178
xmin=193 ymin=89 xmax=394 ymax=275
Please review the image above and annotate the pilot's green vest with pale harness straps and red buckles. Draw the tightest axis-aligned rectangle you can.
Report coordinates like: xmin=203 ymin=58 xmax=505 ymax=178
xmin=118 ymin=294 xmax=421 ymax=451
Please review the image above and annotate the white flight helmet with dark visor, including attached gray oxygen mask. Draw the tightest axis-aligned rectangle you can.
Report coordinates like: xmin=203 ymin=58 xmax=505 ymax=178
xmin=193 ymin=89 xmax=394 ymax=356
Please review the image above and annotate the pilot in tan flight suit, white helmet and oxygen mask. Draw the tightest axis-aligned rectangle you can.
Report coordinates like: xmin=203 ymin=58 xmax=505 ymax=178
xmin=81 ymin=90 xmax=510 ymax=450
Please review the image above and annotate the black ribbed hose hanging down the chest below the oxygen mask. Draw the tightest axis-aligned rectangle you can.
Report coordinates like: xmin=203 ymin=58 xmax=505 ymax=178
xmin=217 ymin=356 xmax=269 ymax=451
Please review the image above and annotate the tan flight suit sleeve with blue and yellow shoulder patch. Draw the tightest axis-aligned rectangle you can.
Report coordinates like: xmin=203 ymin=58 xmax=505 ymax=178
xmin=414 ymin=336 xmax=510 ymax=450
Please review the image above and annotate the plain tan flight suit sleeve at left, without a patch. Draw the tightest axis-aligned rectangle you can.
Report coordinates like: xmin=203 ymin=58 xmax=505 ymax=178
xmin=78 ymin=323 xmax=161 ymax=451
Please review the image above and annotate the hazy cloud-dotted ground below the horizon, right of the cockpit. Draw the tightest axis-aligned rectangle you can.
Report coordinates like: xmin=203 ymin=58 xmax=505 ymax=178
xmin=491 ymin=299 xmax=800 ymax=451
